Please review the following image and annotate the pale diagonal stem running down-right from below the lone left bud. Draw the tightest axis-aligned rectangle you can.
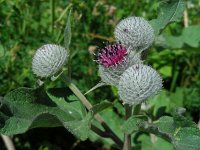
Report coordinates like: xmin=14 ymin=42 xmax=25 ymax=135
xmin=62 ymin=75 xmax=123 ymax=148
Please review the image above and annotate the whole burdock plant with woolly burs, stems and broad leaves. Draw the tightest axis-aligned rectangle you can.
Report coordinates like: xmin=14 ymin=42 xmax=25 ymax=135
xmin=0 ymin=1 xmax=200 ymax=150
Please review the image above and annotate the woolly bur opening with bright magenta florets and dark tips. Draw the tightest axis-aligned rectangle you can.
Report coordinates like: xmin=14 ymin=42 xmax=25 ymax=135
xmin=97 ymin=43 xmax=142 ymax=86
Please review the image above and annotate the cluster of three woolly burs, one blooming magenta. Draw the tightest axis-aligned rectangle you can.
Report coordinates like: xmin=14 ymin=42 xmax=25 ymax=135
xmin=97 ymin=17 xmax=162 ymax=105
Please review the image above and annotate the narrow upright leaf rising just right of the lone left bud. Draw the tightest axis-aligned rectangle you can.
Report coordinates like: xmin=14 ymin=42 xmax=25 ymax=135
xmin=64 ymin=9 xmax=71 ymax=49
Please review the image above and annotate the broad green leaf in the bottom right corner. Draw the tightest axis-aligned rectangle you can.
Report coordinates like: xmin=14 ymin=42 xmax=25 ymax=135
xmin=139 ymin=113 xmax=200 ymax=150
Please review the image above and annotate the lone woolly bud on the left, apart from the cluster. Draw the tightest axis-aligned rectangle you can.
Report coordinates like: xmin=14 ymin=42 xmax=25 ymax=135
xmin=32 ymin=44 xmax=68 ymax=77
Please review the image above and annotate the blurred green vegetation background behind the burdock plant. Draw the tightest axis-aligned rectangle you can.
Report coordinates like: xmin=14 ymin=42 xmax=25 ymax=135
xmin=0 ymin=0 xmax=200 ymax=150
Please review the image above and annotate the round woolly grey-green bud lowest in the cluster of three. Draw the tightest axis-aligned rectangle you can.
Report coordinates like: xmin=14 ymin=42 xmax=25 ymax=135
xmin=118 ymin=64 xmax=162 ymax=105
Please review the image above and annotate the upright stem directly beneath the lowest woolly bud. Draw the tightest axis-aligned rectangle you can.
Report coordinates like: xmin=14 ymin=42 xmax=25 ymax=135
xmin=123 ymin=104 xmax=132 ymax=150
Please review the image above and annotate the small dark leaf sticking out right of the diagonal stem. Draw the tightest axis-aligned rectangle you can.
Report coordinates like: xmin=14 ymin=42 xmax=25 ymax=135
xmin=91 ymin=100 xmax=113 ymax=114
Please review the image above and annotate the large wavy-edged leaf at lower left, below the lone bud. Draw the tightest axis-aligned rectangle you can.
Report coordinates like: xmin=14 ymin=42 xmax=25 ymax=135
xmin=0 ymin=87 xmax=92 ymax=140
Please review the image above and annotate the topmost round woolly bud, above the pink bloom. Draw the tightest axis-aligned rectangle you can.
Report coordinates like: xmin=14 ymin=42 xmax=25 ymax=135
xmin=114 ymin=17 xmax=154 ymax=51
